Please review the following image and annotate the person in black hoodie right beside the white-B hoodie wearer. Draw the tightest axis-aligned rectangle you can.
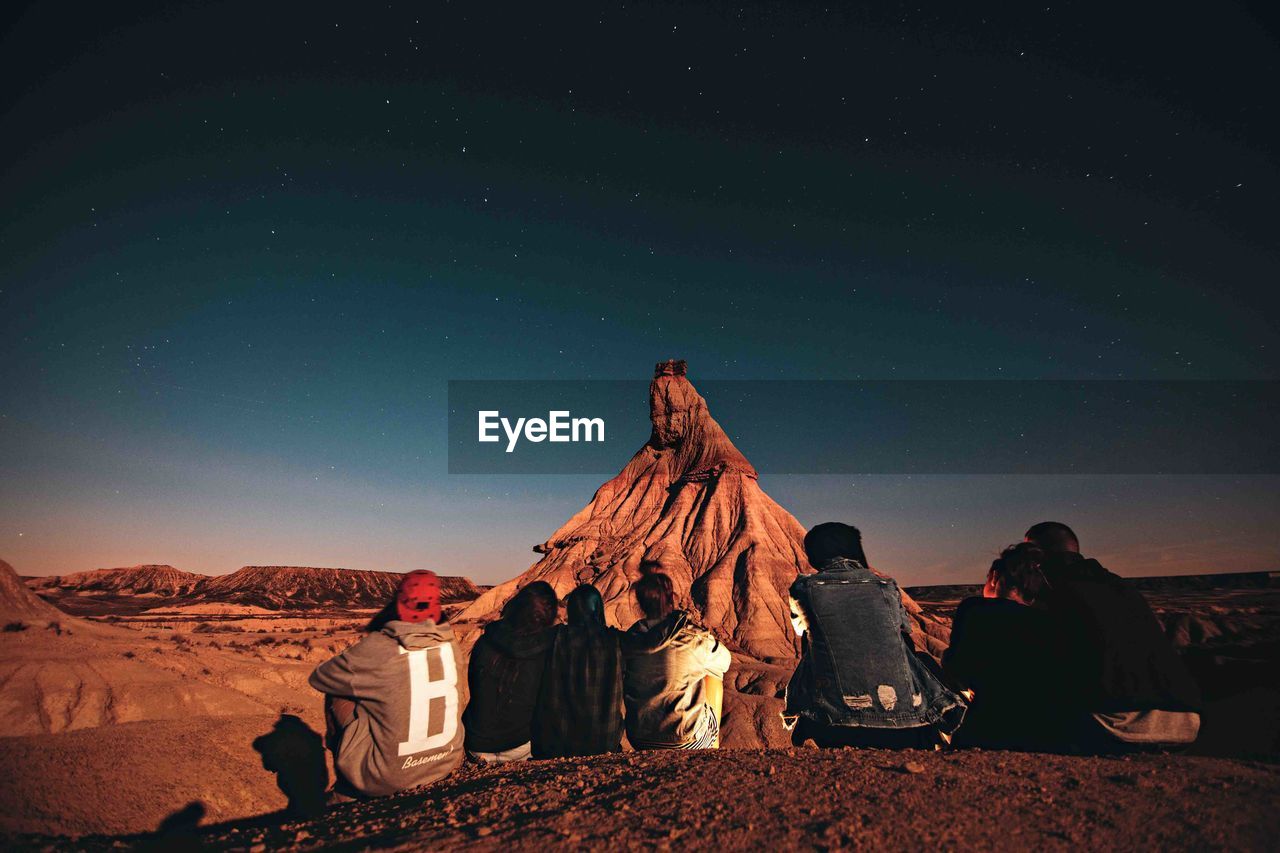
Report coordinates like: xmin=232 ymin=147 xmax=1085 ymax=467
xmin=462 ymin=580 xmax=559 ymax=763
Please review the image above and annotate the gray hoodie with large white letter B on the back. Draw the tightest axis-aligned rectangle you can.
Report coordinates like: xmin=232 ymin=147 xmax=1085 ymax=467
xmin=310 ymin=620 xmax=462 ymax=795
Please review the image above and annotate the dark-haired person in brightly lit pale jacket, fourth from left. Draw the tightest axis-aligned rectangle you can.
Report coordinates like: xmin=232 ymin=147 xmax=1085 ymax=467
xmin=622 ymin=571 xmax=732 ymax=749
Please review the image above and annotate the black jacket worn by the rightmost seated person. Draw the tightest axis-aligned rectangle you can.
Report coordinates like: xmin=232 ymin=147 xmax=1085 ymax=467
xmin=1038 ymin=553 xmax=1201 ymax=712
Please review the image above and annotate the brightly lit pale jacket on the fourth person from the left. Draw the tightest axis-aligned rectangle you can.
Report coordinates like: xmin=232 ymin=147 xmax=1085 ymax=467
xmin=622 ymin=610 xmax=732 ymax=747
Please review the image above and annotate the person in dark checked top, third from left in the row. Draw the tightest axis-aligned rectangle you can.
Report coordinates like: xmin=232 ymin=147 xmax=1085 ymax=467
xmin=532 ymin=584 xmax=622 ymax=758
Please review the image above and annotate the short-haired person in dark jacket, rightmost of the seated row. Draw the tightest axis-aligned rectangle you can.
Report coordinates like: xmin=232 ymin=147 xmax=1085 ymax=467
xmin=1027 ymin=521 xmax=1201 ymax=752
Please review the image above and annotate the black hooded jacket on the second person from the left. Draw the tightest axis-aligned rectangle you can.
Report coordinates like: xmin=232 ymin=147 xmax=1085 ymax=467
xmin=462 ymin=619 xmax=556 ymax=752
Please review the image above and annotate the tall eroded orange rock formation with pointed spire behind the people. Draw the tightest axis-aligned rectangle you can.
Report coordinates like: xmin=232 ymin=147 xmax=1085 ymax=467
xmin=458 ymin=360 xmax=948 ymax=660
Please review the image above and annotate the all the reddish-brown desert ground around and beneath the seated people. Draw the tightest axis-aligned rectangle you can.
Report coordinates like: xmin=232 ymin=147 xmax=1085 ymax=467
xmin=0 ymin=560 xmax=1280 ymax=849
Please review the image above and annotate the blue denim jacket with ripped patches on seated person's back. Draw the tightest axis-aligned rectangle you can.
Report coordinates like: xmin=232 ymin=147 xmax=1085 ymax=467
xmin=785 ymin=560 xmax=965 ymax=733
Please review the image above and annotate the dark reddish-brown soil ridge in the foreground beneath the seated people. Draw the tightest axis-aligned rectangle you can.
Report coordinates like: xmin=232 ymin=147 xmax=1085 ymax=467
xmin=30 ymin=749 xmax=1280 ymax=850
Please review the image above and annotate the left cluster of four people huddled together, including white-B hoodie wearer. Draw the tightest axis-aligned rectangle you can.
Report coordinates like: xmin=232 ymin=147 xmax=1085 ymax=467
xmin=310 ymin=560 xmax=731 ymax=798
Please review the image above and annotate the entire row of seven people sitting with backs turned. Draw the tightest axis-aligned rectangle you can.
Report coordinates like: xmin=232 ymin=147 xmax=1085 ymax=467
xmin=311 ymin=523 xmax=1199 ymax=795
